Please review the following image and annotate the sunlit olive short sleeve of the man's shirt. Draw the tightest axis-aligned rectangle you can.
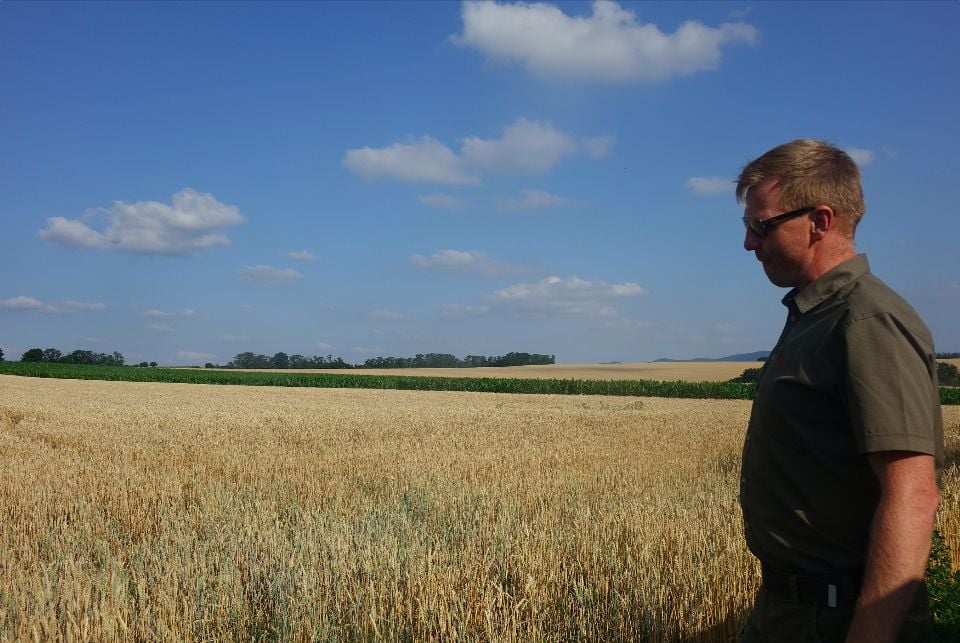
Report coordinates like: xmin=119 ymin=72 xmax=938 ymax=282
xmin=846 ymin=313 xmax=940 ymax=455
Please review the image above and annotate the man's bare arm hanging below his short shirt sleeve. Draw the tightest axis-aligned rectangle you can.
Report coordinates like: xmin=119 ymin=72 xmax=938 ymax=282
xmin=847 ymin=451 xmax=940 ymax=643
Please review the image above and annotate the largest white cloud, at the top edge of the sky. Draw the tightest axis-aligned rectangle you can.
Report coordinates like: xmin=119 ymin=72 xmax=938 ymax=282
xmin=451 ymin=0 xmax=758 ymax=83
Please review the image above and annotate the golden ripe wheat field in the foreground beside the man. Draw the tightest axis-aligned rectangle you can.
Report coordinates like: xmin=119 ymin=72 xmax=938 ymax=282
xmin=0 ymin=376 xmax=960 ymax=641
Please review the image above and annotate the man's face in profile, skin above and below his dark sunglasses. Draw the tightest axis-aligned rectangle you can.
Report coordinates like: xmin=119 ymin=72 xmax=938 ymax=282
xmin=743 ymin=178 xmax=813 ymax=288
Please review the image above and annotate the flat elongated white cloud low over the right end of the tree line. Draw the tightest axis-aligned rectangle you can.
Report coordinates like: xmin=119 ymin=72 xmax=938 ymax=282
xmin=489 ymin=276 xmax=646 ymax=318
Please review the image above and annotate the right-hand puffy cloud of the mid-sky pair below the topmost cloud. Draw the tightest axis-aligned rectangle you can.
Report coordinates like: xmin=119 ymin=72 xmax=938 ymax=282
xmin=461 ymin=118 xmax=579 ymax=174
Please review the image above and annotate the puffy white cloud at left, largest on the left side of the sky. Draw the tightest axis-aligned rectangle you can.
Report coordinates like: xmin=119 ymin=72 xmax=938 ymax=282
xmin=37 ymin=188 xmax=244 ymax=255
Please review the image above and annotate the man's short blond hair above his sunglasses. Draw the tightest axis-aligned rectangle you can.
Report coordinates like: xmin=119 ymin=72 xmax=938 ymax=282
xmin=737 ymin=139 xmax=867 ymax=239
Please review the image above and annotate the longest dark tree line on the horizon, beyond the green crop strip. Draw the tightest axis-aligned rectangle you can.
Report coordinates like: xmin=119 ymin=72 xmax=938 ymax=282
xmin=214 ymin=352 xmax=556 ymax=369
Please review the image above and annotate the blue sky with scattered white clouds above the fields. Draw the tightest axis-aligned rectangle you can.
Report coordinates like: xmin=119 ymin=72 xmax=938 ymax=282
xmin=0 ymin=1 xmax=960 ymax=364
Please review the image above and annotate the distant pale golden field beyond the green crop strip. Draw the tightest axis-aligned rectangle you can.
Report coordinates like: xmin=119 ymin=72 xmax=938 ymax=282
xmin=238 ymin=362 xmax=762 ymax=382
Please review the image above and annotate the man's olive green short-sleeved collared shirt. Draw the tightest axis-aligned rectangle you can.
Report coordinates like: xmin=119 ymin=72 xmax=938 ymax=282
xmin=740 ymin=255 xmax=943 ymax=575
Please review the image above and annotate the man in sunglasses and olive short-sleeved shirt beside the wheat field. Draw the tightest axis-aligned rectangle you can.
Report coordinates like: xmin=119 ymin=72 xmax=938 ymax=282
xmin=737 ymin=140 xmax=943 ymax=643
